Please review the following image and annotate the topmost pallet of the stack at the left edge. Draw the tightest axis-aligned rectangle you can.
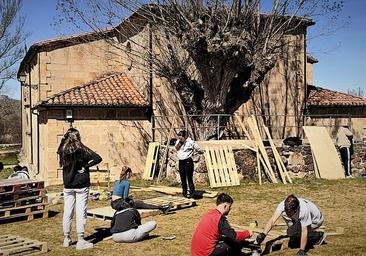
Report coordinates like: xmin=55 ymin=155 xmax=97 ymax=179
xmin=0 ymin=179 xmax=44 ymax=195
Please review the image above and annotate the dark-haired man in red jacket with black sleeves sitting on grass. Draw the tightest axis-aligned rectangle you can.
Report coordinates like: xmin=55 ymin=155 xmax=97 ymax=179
xmin=191 ymin=193 xmax=252 ymax=256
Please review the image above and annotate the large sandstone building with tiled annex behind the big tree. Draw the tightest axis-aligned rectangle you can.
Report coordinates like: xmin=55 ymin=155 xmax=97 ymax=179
xmin=18 ymin=8 xmax=313 ymax=185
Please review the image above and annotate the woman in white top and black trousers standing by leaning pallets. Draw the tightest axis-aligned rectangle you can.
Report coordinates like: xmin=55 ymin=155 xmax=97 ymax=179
xmin=175 ymin=130 xmax=200 ymax=198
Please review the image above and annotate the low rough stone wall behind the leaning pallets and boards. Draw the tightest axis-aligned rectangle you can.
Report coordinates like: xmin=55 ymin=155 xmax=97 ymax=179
xmin=167 ymin=144 xmax=366 ymax=183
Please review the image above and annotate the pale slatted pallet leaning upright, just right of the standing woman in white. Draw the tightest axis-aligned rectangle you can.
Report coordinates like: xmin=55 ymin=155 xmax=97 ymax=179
xmin=205 ymin=146 xmax=240 ymax=188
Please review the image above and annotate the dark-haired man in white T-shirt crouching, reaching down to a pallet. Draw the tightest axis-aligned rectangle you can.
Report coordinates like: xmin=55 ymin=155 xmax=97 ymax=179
xmin=256 ymin=195 xmax=325 ymax=255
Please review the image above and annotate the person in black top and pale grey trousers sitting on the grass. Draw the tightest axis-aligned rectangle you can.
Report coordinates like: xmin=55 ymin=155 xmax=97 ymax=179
xmin=110 ymin=198 xmax=156 ymax=243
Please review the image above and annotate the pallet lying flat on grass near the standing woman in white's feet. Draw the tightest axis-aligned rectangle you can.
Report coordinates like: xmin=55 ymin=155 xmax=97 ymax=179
xmin=142 ymin=196 xmax=197 ymax=210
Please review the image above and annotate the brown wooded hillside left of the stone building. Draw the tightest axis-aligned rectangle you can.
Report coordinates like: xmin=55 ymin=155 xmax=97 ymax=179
xmin=0 ymin=95 xmax=22 ymax=144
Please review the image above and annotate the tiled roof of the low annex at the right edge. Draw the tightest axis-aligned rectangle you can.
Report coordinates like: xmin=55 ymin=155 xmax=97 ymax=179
xmin=308 ymin=86 xmax=366 ymax=106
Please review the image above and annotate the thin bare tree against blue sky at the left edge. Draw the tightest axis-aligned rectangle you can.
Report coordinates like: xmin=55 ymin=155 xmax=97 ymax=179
xmin=0 ymin=0 xmax=27 ymax=91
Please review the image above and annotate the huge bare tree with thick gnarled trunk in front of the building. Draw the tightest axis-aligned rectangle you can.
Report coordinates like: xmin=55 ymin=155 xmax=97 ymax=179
xmin=58 ymin=0 xmax=343 ymax=139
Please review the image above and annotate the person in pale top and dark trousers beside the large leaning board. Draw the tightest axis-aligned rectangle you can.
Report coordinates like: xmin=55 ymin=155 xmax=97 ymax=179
xmin=336 ymin=126 xmax=353 ymax=178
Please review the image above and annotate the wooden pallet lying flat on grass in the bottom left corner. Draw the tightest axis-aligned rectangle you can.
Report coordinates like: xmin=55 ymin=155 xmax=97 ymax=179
xmin=0 ymin=235 xmax=48 ymax=256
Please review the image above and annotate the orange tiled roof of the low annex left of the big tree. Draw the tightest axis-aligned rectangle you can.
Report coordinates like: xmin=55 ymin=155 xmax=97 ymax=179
xmin=37 ymin=73 xmax=147 ymax=107
